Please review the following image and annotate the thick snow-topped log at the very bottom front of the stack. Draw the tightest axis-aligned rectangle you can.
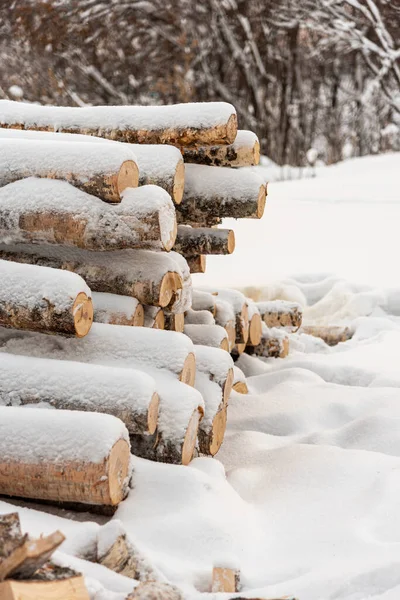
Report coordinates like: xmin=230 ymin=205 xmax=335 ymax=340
xmin=0 ymin=407 xmax=130 ymax=506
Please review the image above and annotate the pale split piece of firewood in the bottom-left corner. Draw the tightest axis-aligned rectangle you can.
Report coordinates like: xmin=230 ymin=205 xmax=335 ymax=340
xmin=0 ymin=575 xmax=90 ymax=600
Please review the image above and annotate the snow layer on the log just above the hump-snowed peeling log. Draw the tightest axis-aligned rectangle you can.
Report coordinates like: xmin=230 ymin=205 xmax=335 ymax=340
xmin=0 ymin=137 xmax=136 ymax=179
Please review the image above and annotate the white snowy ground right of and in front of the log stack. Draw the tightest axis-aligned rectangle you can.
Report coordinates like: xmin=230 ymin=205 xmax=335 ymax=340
xmin=0 ymin=154 xmax=400 ymax=600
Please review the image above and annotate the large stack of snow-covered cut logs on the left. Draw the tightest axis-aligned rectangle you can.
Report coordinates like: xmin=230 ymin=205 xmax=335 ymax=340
xmin=0 ymin=100 xmax=272 ymax=506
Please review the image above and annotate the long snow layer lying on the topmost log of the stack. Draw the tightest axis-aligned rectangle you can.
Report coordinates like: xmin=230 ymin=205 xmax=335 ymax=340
xmin=0 ymin=100 xmax=236 ymax=136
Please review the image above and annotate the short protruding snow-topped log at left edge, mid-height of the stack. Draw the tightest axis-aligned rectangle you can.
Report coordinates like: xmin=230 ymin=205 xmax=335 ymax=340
xmin=0 ymin=260 xmax=93 ymax=337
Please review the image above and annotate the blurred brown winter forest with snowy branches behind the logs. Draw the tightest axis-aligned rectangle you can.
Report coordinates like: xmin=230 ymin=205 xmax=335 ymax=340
xmin=0 ymin=0 xmax=400 ymax=166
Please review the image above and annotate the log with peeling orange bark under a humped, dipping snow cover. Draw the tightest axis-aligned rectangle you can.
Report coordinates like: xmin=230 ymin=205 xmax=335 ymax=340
xmin=0 ymin=177 xmax=172 ymax=251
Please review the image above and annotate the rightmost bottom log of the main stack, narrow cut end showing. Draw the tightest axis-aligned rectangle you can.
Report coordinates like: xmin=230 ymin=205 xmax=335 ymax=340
xmin=195 ymin=371 xmax=226 ymax=456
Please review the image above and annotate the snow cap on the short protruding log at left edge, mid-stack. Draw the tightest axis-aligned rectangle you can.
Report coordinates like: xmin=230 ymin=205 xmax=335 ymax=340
xmin=0 ymin=260 xmax=91 ymax=311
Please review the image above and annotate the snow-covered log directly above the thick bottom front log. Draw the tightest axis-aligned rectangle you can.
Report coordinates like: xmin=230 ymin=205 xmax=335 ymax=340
xmin=0 ymin=353 xmax=159 ymax=433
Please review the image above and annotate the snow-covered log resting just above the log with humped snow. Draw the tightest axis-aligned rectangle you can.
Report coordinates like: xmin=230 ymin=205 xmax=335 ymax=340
xmin=0 ymin=136 xmax=139 ymax=202
